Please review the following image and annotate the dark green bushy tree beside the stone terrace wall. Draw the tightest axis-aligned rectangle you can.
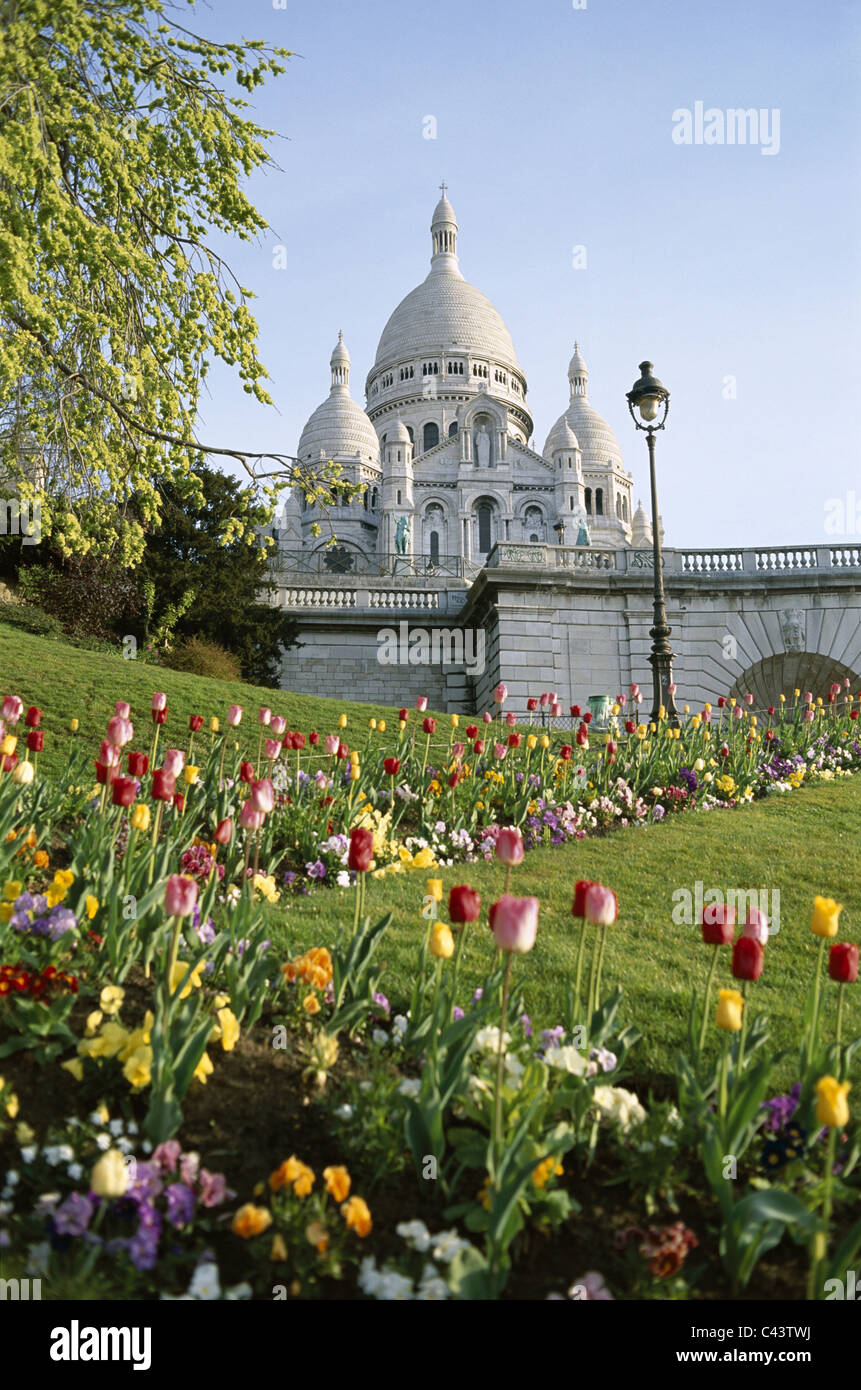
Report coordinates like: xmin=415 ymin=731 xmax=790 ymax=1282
xmin=132 ymin=466 xmax=296 ymax=685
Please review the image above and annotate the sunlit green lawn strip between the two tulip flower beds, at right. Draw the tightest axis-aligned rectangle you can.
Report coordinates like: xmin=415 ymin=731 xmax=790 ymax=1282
xmin=271 ymin=777 xmax=861 ymax=1086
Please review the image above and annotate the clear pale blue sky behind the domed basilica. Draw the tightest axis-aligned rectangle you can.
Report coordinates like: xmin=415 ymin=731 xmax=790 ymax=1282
xmin=190 ymin=0 xmax=861 ymax=546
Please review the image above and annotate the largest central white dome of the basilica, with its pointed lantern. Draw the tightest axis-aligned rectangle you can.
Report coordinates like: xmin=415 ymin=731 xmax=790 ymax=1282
xmin=374 ymin=192 xmax=519 ymax=373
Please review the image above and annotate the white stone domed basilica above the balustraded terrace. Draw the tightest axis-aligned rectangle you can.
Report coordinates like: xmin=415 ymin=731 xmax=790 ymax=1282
xmin=278 ymin=185 xmax=651 ymax=573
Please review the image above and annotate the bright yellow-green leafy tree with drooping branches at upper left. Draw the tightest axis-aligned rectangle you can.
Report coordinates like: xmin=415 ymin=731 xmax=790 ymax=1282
xmin=0 ymin=0 xmax=356 ymax=564
